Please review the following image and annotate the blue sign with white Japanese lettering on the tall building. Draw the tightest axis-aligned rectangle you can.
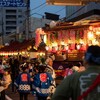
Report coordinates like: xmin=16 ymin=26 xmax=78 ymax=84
xmin=0 ymin=0 xmax=27 ymax=7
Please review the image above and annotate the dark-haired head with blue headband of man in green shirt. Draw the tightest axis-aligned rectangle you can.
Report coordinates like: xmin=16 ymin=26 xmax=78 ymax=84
xmin=84 ymin=45 xmax=100 ymax=65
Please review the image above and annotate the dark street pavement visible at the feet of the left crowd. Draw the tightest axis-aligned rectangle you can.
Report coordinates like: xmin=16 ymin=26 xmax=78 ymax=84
xmin=5 ymin=86 xmax=34 ymax=100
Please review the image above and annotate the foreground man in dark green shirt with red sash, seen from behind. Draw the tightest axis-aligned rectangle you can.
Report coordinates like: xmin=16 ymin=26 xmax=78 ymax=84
xmin=51 ymin=45 xmax=100 ymax=100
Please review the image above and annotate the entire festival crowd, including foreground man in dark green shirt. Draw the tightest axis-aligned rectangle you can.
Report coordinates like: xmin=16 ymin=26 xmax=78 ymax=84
xmin=0 ymin=46 xmax=100 ymax=100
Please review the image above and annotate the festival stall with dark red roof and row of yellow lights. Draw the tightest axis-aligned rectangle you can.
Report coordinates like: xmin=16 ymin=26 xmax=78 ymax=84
xmin=0 ymin=39 xmax=37 ymax=58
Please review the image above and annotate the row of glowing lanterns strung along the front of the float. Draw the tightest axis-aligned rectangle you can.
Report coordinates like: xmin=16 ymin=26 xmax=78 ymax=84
xmin=46 ymin=26 xmax=100 ymax=52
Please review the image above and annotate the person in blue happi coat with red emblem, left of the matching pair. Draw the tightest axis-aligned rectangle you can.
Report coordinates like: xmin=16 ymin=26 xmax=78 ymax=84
xmin=15 ymin=63 xmax=32 ymax=100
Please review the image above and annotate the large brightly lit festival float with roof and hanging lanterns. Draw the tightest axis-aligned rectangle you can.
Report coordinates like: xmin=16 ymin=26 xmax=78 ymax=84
xmin=35 ymin=20 xmax=100 ymax=75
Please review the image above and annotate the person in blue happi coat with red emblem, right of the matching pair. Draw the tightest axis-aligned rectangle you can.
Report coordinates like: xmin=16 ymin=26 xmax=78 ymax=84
xmin=33 ymin=64 xmax=53 ymax=100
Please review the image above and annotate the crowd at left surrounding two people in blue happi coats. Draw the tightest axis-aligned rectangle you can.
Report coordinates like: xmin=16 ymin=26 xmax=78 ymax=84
xmin=0 ymin=54 xmax=56 ymax=100
